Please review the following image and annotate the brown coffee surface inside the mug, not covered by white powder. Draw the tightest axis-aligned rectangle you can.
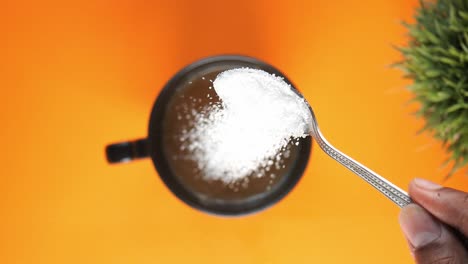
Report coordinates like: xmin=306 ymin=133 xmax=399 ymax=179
xmin=162 ymin=67 xmax=299 ymax=200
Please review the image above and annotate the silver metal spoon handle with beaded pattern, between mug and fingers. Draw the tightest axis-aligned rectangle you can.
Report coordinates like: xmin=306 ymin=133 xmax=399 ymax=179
xmin=312 ymin=127 xmax=412 ymax=207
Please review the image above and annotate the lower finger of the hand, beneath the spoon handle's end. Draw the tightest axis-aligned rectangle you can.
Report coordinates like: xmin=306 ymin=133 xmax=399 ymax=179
xmin=399 ymin=204 xmax=468 ymax=264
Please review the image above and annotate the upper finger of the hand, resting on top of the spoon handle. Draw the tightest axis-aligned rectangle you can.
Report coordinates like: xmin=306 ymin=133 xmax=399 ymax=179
xmin=409 ymin=179 xmax=468 ymax=236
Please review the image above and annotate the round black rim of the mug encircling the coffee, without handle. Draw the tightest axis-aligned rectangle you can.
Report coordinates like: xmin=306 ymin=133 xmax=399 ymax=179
xmin=147 ymin=55 xmax=312 ymax=216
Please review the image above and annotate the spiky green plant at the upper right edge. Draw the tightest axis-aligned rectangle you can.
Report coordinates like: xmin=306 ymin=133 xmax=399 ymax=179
xmin=397 ymin=0 xmax=468 ymax=174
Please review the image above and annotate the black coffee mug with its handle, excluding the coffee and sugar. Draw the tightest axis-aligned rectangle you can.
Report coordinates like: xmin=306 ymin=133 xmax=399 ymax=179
xmin=106 ymin=55 xmax=312 ymax=216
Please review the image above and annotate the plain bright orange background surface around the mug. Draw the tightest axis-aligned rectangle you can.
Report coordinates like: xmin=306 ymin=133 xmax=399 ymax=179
xmin=0 ymin=0 xmax=468 ymax=264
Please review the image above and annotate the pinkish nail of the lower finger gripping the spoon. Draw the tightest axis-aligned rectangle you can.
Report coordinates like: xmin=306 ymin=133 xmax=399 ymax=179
xmin=399 ymin=204 xmax=442 ymax=249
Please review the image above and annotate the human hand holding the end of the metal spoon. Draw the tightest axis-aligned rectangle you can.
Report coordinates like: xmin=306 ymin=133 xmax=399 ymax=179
xmin=400 ymin=179 xmax=468 ymax=264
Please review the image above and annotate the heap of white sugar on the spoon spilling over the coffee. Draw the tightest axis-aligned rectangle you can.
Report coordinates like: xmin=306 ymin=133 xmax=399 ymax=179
xmin=181 ymin=68 xmax=311 ymax=183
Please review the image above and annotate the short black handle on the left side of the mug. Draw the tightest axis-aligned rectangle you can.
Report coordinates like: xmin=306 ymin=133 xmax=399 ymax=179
xmin=106 ymin=138 xmax=149 ymax=163
